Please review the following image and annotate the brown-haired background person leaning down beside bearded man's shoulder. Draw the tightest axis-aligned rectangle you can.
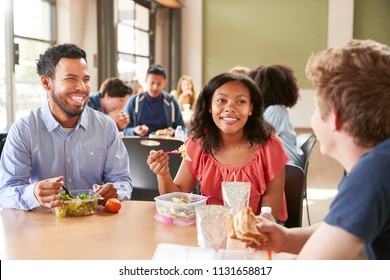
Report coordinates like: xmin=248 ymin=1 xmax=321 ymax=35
xmin=88 ymin=78 xmax=133 ymax=131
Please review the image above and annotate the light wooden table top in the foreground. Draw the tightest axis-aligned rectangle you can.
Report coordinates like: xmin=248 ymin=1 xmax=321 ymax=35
xmin=0 ymin=201 xmax=197 ymax=260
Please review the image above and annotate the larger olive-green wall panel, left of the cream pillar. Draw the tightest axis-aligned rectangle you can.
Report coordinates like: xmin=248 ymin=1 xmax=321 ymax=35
xmin=203 ymin=0 xmax=328 ymax=88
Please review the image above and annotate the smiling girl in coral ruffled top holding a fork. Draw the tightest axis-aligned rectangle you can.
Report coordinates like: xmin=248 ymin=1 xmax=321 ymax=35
xmin=147 ymin=73 xmax=289 ymax=222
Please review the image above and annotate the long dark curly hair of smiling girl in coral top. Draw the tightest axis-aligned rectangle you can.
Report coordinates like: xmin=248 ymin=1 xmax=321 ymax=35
xmin=190 ymin=73 xmax=274 ymax=153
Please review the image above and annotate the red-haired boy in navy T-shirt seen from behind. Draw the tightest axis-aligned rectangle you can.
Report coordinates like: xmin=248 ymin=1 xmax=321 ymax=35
xmin=251 ymin=40 xmax=390 ymax=260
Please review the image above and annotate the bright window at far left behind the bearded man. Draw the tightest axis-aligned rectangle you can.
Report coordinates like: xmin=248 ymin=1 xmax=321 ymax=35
xmin=0 ymin=0 xmax=55 ymax=130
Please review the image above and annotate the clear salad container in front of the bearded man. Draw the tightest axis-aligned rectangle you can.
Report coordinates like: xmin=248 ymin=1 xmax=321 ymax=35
xmin=53 ymin=189 xmax=103 ymax=218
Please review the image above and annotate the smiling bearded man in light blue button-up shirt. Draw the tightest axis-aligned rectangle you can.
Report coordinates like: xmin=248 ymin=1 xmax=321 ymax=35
xmin=0 ymin=44 xmax=132 ymax=210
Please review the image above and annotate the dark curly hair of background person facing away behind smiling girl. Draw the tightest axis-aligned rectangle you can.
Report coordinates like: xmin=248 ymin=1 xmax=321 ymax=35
xmin=248 ymin=64 xmax=299 ymax=108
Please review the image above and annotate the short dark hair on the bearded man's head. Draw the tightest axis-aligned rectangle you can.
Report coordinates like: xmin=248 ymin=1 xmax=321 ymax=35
xmin=36 ymin=44 xmax=87 ymax=79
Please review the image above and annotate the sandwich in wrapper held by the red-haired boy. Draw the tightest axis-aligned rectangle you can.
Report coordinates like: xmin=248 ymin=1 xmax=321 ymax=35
xmin=229 ymin=207 xmax=268 ymax=247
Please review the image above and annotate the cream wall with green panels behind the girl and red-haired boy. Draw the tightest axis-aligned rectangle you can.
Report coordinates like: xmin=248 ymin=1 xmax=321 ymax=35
xmin=198 ymin=0 xmax=390 ymax=128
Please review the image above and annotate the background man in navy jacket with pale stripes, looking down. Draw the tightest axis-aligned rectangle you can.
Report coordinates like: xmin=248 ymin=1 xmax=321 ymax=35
xmin=123 ymin=64 xmax=185 ymax=136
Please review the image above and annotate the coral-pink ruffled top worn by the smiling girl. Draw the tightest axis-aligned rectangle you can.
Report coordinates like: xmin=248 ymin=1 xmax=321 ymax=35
xmin=185 ymin=134 xmax=289 ymax=221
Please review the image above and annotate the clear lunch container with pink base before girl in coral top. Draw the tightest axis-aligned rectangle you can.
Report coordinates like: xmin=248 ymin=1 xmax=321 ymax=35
xmin=154 ymin=192 xmax=207 ymax=225
